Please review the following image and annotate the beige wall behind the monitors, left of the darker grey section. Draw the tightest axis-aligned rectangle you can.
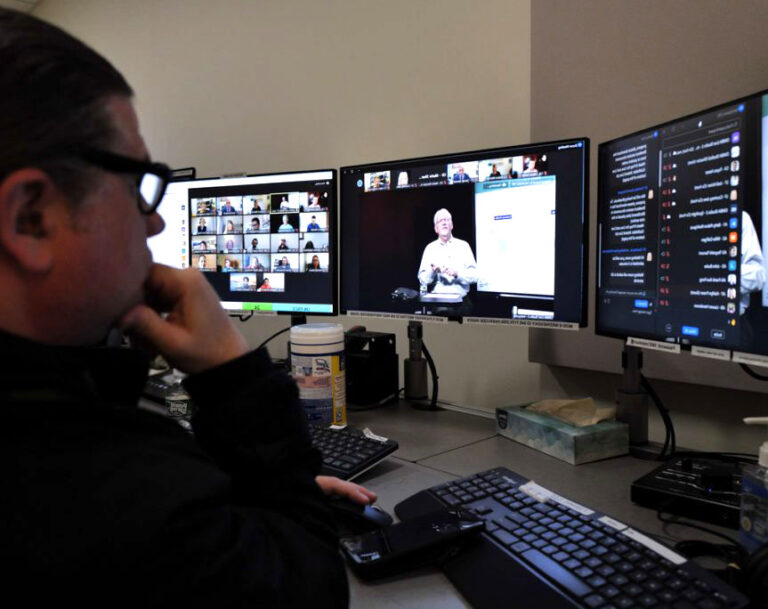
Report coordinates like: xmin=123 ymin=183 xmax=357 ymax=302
xmin=34 ymin=0 xmax=541 ymax=409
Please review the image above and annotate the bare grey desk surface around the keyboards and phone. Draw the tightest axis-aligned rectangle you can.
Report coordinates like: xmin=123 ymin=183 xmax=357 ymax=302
xmin=349 ymin=402 xmax=735 ymax=609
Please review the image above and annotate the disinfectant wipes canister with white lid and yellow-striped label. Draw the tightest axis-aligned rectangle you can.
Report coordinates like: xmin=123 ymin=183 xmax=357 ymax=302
xmin=291 ymin=324 xmax=347 ymax=425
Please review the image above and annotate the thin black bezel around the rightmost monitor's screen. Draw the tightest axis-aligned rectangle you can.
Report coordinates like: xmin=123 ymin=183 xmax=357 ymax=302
xmin=593 ymin=89 xmax=768 ymax=351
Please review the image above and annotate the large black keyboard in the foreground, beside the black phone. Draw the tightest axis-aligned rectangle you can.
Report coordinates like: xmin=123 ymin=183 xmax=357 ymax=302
xmin=395 ymin=467 xmax=748 ymax=609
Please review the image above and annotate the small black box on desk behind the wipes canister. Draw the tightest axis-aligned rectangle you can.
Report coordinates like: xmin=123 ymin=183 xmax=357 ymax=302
xmin=345 ymin=332 xmax=400 ymax=407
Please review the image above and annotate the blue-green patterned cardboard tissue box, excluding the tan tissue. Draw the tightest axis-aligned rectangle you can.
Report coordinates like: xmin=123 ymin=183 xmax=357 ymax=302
xmin=496 ymin=406 xmax=629 ymax=465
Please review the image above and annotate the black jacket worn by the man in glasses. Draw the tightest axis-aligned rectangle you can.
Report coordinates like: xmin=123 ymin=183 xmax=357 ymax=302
xmin=0 ymin=334 xmax=348 ymax=609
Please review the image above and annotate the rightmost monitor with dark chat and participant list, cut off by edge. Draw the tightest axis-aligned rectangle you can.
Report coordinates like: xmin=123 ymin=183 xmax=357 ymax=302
xmin=596 ymin=91 xmax=768 ymax=354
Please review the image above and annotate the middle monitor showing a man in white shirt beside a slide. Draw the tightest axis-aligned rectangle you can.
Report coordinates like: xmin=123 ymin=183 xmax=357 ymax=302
xmin=340 ymin=138 xmax=589 ymax=328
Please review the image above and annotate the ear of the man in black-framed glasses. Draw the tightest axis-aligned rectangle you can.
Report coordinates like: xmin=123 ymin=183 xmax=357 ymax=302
xmin=0 ymin=168 xmax=65 ymax=272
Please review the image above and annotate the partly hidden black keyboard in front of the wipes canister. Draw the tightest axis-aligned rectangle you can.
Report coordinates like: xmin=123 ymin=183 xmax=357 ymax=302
xmin=309 ymin=424 xmax=398 ymax=480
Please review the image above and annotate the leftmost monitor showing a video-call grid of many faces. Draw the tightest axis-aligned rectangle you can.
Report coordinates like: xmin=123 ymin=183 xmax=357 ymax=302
xmin=149 ymin=169 xmax=338 ymax=315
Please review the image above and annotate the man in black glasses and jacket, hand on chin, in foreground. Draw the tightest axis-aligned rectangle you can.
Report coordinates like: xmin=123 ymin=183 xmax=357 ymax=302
xmin=0 ymin=9 xmax=373 ymax=607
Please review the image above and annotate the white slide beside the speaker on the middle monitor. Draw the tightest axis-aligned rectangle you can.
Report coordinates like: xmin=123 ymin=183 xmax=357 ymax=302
xmin=475 ymin=176 xmax=556 ymax=297
